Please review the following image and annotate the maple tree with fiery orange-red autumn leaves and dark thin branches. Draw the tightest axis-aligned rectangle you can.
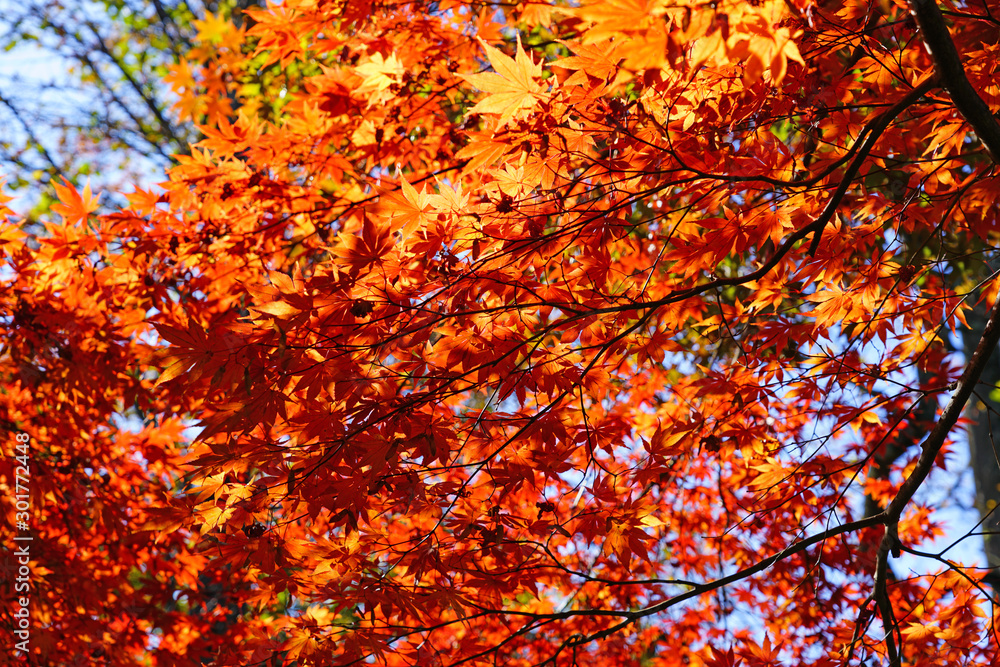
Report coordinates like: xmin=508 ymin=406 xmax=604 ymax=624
xmin=2 ymin=0 xmax=1000 ymax=666
